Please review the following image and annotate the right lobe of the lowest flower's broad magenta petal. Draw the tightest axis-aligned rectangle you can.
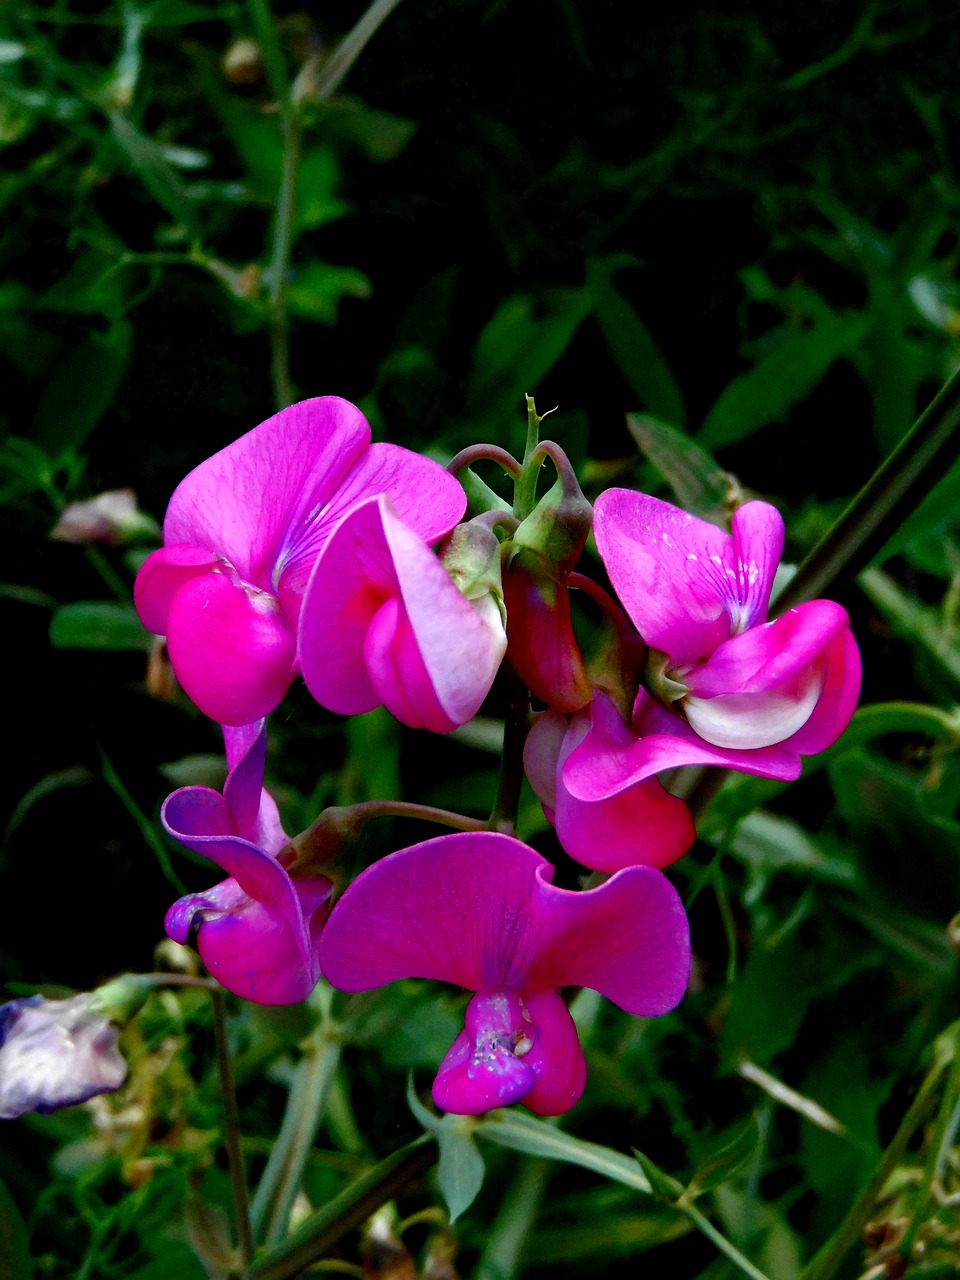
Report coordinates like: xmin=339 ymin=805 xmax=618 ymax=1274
xmin=526 ymin=867 xmax=690 ymax=1018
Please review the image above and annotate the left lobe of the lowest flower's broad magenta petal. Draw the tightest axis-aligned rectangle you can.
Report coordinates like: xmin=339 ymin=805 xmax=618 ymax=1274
xmin=320 ymin=832 xmax=553 ymax=991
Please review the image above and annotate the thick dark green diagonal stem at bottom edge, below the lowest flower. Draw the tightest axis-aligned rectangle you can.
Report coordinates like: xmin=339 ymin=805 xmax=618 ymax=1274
xmin=242 ymin=1134 xmax=438 ymax=1280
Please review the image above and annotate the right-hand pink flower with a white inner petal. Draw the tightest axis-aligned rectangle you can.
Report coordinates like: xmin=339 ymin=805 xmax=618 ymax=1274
xmin=586 ymin=489 xmax=860 ymax=773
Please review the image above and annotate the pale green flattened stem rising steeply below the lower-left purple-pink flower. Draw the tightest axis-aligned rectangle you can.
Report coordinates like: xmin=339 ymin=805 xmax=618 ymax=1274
xmin=251 ymin=1024 xmax=340 ymax=1244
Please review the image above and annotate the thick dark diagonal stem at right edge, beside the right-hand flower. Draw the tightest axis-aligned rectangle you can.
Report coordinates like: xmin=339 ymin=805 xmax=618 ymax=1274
xmin=771 ymin=360 xmax=960 ymax=617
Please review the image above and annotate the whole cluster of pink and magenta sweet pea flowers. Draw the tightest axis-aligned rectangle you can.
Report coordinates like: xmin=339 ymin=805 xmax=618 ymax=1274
xmin=129 ymin=398 xmax=860 ymax=1115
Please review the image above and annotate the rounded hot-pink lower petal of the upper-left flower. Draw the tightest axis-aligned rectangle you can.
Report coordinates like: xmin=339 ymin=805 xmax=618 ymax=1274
xmin=166 ymin=573 xmax=296 ymax=724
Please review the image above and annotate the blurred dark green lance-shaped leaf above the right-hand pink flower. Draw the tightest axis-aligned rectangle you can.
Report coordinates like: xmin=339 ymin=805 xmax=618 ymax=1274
xmin=696 ymin=314 xmax=870 ymax=449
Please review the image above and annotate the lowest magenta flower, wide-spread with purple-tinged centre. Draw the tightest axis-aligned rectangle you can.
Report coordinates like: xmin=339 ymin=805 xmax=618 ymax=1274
xmin=320 ymin=832 xmax=690 ymax=1115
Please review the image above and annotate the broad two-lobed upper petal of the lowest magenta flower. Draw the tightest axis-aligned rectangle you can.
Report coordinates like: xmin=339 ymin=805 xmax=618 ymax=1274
xmin=320 ymin=832 xmax=690 ymax=1015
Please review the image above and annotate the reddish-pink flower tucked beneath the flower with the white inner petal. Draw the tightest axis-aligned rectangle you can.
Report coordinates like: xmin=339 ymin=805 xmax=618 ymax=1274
xmin=524 ymin=690 xmax=695 ymax=872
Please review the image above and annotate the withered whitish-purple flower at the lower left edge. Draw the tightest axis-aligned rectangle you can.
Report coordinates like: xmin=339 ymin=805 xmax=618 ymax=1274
xmin=0 ymin=992 xmax=127 ymax=1120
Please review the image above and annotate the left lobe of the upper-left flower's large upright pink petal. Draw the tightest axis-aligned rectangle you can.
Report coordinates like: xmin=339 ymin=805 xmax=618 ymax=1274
xmin=164 ymin=396 xmax=370 ymax=586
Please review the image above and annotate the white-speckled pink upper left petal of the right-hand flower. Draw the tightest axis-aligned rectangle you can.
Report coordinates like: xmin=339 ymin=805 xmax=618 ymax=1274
xmin=594 ymin=489 xmax=739 ymax=664
